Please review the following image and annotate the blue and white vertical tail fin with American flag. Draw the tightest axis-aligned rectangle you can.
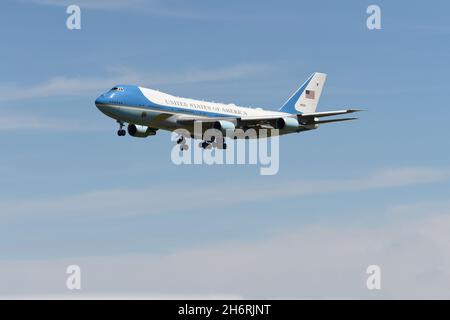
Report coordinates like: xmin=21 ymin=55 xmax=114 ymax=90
xmin=279 ymin=72 xmax=327 ymax=114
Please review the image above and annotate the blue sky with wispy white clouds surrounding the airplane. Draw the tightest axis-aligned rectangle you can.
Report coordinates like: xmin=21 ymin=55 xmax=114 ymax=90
xmin=0 ymin=0 xmax=450 ymax=299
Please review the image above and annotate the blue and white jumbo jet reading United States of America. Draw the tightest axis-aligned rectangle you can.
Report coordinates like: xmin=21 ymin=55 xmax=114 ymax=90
xmin=95 ymin=72 xmax=360 ymax=150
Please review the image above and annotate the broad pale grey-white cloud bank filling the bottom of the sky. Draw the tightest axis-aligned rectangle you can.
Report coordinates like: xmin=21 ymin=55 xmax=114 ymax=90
xmin=0 ymin=201 xmax=450 ymax=299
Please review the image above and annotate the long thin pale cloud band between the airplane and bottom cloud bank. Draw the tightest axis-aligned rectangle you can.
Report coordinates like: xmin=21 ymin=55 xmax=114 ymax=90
xmin=0 ymin=167 xmax=450 ymax=217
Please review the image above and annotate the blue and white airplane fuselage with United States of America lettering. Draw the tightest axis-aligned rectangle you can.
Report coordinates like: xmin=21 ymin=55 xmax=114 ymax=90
xmin=95 ymin=85 xmax=292 ymax=134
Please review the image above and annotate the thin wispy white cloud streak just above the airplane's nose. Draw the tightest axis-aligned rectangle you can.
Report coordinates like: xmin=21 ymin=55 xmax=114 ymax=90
xmin=0 ymin=64 xmax=270 ymax=101
